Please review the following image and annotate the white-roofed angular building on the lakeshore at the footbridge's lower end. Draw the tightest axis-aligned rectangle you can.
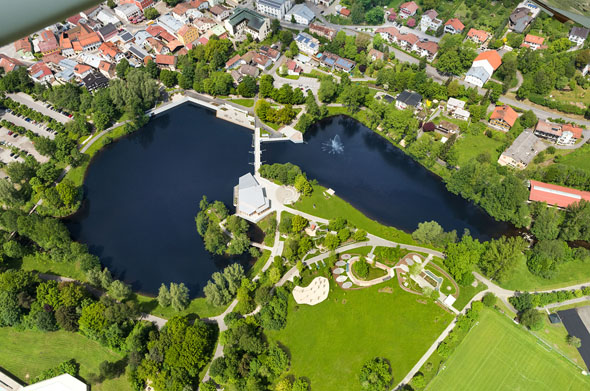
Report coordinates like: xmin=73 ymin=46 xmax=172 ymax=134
xmin=234 ymin=173 xmax=270 ymax=220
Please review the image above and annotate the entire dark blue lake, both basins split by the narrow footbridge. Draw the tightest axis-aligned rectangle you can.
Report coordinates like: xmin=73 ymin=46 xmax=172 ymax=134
xmin=67 ymin=105 xmax=508 ymax=296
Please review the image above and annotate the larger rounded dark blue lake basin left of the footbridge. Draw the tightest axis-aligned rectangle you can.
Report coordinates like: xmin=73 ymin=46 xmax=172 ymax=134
xmin=67 ymin=105 xmax=253 ymax=295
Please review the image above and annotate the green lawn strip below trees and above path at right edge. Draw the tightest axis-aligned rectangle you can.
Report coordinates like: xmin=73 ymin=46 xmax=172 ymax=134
xmin=497 ymin=255 xmax=590 ymax=291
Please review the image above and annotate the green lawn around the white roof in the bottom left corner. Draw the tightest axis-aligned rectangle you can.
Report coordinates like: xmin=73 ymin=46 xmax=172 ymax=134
xmin=0 ymin=327 xmax=131 ymax=391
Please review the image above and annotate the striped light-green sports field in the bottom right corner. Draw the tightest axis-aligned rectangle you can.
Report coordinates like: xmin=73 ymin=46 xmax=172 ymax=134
xmin=427 ymin=309 xmax=590 ymax=391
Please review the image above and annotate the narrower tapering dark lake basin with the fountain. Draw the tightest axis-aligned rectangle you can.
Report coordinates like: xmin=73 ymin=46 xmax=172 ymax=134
xmin=263 ymin=116 xmax=509 ymax=239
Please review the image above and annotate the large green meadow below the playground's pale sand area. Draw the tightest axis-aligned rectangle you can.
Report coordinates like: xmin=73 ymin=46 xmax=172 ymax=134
xmin=268 ymin=280 xmax=453 ymax=391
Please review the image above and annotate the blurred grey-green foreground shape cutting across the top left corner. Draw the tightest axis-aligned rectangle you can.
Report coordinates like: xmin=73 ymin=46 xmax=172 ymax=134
xmin=0 ymin=0 xmax=101 ymax=45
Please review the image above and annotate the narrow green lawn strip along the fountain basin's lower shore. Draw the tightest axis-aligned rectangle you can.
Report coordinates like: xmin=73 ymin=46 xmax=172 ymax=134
xmin=293 ymin=185 xmax=426 ymax=244
